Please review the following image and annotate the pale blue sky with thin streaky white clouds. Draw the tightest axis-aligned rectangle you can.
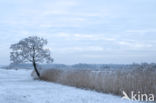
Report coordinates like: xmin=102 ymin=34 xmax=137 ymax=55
xmin=0 ymin=0 xmax=156 ymax=64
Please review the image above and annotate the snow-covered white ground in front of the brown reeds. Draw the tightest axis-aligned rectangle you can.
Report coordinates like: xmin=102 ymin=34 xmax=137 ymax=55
xmin=0 ymin=69 xmax=144 ymax=103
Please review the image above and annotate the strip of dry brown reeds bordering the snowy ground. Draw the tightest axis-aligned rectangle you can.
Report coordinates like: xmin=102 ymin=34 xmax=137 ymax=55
xmin=32 ymin=69 xmax=156 ymax=98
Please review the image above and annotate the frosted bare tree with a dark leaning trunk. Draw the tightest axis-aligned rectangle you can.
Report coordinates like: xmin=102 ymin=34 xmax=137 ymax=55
xmin=10 ymin=36 xmax=53 ymax=78
